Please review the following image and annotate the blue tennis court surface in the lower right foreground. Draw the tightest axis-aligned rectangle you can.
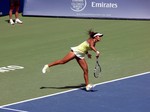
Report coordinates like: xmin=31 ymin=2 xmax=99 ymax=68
xmin=0 ymin=72 xmax=150 ymax=112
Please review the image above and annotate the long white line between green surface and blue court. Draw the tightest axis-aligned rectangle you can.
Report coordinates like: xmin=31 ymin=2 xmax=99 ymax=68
xmin=0 ymin=72 xmax=150 ymax=108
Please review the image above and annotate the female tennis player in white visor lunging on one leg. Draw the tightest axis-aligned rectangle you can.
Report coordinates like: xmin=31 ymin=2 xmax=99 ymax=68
xmin=42 ymin=30 xmax=103 ymax=91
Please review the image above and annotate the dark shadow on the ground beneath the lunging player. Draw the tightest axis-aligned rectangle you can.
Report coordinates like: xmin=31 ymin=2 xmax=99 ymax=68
xmin=40 ymin=84 xmax=97 ymax=92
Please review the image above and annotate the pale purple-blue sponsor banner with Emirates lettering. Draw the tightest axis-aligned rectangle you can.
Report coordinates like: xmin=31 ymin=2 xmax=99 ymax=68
xmin=23 ymin=0 xmax=150 ymax=19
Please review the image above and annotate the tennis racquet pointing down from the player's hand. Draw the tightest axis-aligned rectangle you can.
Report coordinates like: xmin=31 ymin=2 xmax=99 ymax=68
xmin=94 ymin=58 xmax=102 ymax=78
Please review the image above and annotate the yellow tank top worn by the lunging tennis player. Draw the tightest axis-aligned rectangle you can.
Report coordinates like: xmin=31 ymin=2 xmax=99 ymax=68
xmin=76 ymin=41 xmax=91 ymax=53
